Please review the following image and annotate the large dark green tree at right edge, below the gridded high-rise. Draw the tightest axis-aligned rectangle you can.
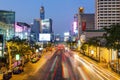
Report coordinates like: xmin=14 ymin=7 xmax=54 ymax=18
xmin=103 ymin=24 xmax=120 ymax=72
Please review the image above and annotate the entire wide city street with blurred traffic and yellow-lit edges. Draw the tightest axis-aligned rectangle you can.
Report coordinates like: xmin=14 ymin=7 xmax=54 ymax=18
xmin=11 ymin=51 xmax=120 ymax=80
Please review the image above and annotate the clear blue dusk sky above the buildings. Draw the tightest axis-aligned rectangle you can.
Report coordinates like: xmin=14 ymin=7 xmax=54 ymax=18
xmin=0 ymin=0 xmax=95 ymax=35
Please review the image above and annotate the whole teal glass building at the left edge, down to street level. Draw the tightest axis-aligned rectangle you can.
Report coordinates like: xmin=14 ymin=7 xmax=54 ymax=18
xmin=0 ymin=10 xmax=15 ymax=57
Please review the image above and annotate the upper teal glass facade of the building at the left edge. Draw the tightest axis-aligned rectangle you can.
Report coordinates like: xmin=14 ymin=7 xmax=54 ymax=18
xmin=0 ymin=10 xmax=15 ymax=40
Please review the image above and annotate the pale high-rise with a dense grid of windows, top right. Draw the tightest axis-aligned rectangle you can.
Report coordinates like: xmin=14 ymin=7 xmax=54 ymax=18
xmin=95 ymin=0 xmax=120 ymax=29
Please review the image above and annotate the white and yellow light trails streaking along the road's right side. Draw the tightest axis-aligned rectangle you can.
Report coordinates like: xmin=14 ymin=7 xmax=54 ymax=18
xmin=74 ymin=54 xmax=120 ymax=80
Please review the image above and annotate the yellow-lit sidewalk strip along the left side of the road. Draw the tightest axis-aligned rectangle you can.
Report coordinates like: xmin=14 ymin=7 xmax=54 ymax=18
xmin=10 ymin=52 xmax=53 ymax=80
